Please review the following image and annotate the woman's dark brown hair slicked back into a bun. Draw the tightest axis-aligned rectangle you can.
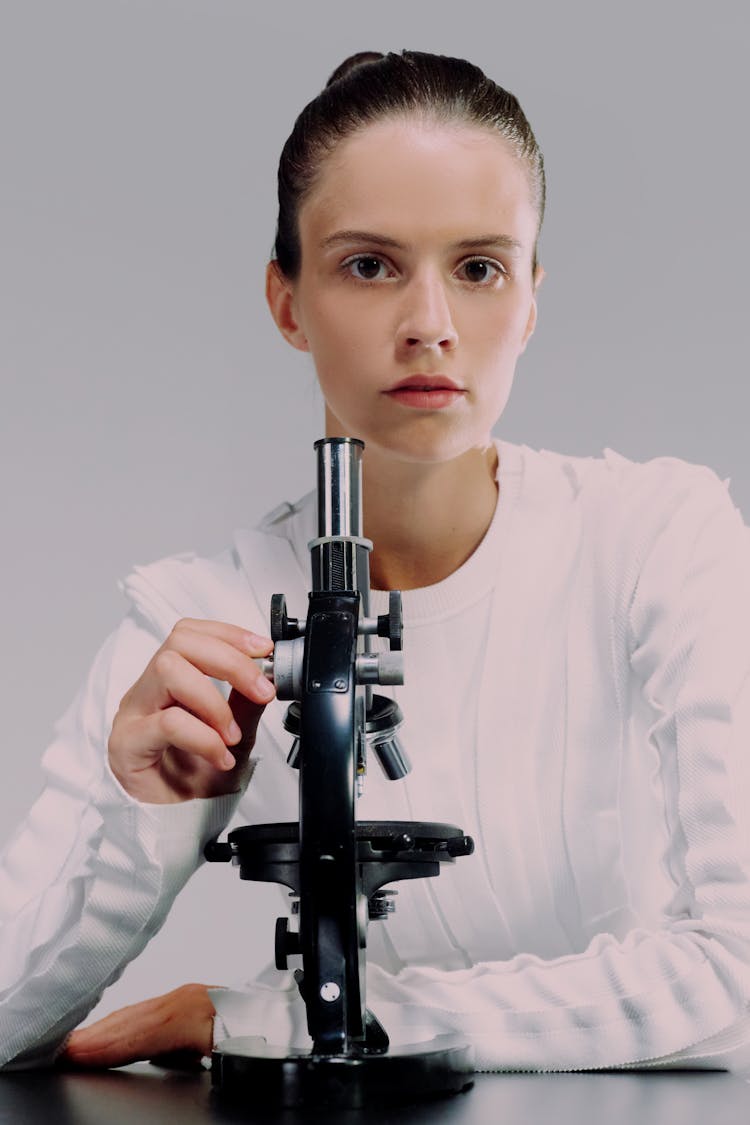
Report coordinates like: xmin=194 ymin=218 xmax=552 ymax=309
xmin=274 ymin=51 xmax=545 ymax=280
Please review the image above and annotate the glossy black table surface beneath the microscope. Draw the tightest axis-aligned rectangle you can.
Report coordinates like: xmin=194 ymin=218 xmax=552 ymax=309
xmin=0 ymin=1063 xmax=750 ymax=1125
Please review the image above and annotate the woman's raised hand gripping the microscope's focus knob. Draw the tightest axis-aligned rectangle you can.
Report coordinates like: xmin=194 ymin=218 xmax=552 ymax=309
xmin=109 ymin=618 xmax=275 ymax=804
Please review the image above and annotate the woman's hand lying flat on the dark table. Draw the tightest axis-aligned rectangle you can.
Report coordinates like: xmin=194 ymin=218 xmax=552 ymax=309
xmin=57 ymin=984 xmax=216 ymax=1068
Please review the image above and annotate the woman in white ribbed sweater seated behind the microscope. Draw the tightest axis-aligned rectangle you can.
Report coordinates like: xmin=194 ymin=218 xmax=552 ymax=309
xmin=2 ymin=52 xmax=750 ymax=1070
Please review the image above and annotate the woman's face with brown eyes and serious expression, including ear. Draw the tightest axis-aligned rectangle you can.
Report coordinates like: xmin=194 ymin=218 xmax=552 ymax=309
xmin=268 ymin=119 xmax=542 ymax=462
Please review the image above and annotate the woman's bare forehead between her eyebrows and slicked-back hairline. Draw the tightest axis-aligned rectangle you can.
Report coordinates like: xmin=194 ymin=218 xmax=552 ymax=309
xmin=299 ymin=119 xmax=536 ymax=251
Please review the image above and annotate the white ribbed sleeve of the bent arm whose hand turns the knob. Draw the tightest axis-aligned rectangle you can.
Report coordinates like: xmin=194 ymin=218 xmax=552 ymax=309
xmin=0 ymin=617 xmax=238 ymax=1068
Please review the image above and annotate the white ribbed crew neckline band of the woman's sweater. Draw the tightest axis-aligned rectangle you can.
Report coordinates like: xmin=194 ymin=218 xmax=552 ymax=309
xmin=370 ymin=438 xmax=524 ymax=626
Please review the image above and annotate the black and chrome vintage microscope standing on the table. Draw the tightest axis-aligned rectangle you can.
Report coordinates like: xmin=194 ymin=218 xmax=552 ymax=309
xmin=206 ymin=438 xmax=473 ymax=1108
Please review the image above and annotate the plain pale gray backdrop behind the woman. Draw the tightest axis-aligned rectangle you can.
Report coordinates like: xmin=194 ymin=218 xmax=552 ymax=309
xmin=0 ymin=0 xmax=750 ymax=1014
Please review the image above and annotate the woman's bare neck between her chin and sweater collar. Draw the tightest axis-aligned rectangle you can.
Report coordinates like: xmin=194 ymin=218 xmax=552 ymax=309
xmin=362 ymin=446 xmax=497 ymax=590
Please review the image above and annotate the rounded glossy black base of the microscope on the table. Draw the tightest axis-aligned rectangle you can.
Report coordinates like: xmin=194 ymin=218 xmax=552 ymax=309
xmin=211 ymin=1035 xmax=473 ymax=1109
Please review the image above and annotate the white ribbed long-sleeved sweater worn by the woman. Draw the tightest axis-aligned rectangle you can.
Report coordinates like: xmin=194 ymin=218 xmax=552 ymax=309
xmin=0 ymin=442 xmax=750 ymax=1070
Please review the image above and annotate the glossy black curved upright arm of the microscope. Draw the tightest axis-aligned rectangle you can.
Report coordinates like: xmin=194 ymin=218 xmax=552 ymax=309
xmin=299 ymin=591 xmax=367 ymax=1054
